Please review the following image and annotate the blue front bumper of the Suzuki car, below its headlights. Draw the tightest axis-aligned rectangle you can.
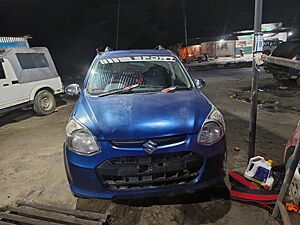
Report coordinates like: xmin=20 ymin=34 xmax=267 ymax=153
xmin=64 ymin=134 xmax=226 ymax=199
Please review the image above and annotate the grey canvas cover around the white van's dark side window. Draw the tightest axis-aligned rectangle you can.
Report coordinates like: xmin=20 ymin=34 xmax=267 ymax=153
xmin=0 ymin=47 xmax=59 ymax=83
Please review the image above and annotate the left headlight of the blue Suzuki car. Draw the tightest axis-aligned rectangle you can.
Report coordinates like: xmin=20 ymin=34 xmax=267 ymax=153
xmin=66 ymin=119 xmax=100 ymax=154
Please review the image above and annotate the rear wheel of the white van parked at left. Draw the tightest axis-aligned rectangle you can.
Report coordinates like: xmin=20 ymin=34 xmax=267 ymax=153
xmin=33 ymin=90 xmax=56 ymax=116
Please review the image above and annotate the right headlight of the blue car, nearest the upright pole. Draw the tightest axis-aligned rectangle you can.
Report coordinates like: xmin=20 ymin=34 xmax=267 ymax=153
xmin=197 ymin=108 xmax=225 ymax=145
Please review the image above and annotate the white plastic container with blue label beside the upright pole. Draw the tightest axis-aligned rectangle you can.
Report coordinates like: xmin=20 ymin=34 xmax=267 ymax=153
xmin=244 ymin=156 xmax=274 ymax=189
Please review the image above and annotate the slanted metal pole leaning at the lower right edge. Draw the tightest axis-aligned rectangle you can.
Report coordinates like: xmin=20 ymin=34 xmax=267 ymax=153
xmin=272 ymin=139 xmax=300 ymax=218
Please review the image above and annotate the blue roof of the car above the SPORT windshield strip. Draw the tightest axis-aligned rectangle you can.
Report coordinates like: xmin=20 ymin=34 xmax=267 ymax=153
xmin=99 ymin=49 xmax=176 ymax=58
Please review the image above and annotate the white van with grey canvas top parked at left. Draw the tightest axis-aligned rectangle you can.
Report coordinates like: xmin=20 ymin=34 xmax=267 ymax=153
xmin=0 ymin=47 xmax=63 ymax=115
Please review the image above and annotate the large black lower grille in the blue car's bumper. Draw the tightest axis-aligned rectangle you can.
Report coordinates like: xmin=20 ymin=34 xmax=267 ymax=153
xmin=97 ymin=151 xmax=203 ymax=190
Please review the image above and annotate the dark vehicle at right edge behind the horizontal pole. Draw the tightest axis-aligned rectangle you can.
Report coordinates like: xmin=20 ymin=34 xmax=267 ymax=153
xmin=265 ymin=40 xmax=300 ymax=87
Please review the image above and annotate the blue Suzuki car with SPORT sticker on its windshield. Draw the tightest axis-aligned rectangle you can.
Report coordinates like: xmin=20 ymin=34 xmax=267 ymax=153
xmin=64 ymin=49 xmax=226 ymax=199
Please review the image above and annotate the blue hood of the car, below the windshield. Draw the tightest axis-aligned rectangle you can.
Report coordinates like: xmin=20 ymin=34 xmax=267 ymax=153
xmin=73 ymin=89 xmax=212 ymax=140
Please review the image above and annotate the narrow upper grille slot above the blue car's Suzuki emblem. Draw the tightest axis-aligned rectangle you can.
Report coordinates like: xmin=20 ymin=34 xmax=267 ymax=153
xmin=111 ymin=135 xmax=186 ymax=148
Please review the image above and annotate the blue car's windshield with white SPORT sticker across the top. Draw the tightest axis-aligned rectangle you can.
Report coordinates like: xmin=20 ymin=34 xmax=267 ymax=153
xmin=87 ymin=56 xmax=191 ymax=95
